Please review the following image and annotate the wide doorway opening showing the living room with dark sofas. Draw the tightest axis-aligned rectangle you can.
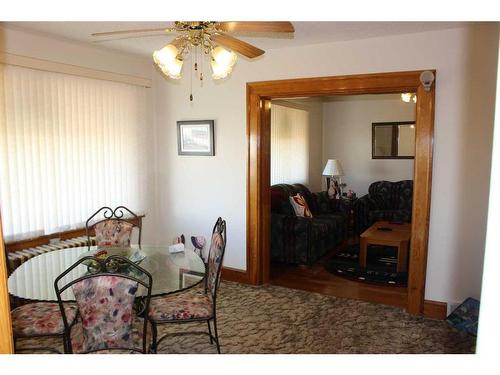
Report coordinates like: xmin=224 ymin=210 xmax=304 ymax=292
xmin=269 ymin=94 xmax=416 ymax=307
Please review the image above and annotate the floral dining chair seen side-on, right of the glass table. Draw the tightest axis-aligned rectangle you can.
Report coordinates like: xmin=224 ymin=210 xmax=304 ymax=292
xmin=148 ymin=217 xmax=226 ymax=354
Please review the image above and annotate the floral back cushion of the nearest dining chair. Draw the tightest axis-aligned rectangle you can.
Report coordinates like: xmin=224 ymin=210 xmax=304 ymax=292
xmin=72 ymin=275 xmax=138 ymax=352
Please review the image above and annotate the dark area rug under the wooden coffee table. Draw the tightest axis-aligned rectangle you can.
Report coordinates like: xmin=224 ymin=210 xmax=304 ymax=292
xmin=325 ymin=244 xmax=408 ymax=286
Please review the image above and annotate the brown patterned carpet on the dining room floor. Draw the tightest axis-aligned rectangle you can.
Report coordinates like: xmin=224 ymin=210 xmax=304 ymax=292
xmin=18 ymin=282 xmax=475 ymax=354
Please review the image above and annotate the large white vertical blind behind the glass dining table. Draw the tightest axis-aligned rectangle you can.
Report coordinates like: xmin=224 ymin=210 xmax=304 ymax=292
xmin=0 ymin=64 xmax=147 ymax=241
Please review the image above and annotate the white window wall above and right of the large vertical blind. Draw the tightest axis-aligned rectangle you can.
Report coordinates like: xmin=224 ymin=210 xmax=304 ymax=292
xmin=0 ymin=24 xmax=157 ymax=243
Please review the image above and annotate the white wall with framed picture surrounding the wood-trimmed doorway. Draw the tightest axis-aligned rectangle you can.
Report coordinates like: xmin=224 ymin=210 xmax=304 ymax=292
xmin=153 ymin=25 xmax=498 ymax=301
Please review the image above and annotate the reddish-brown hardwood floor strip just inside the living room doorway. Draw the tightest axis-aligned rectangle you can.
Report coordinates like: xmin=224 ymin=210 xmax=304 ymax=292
xmin=270 ymin=247 xmax=408 ymax=307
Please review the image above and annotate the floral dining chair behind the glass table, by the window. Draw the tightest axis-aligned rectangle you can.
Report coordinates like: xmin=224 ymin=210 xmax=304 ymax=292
xmin=85 ymin=206 xmax=142 ymax=247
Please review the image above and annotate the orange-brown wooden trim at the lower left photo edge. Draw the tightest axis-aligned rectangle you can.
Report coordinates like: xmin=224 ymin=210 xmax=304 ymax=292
xmin=0 ymin=215 xmax=14 ymax=354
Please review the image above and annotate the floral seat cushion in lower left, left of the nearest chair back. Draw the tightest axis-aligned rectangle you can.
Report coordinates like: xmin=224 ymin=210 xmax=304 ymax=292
xmin=11 ymin=302 xmax=78 ymax=337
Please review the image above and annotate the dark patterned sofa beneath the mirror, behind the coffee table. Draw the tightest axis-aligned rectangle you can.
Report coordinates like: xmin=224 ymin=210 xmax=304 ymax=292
xmin=354 ymin=180 xmax=413 ymax=234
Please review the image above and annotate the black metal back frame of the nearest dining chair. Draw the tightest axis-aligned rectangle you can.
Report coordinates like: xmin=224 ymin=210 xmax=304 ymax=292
xmin=54 ymin=255 xmax=153 ymax=353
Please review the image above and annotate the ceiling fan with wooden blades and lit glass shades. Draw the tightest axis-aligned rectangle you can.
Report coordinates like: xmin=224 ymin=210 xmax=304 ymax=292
xmin=92 ymin=21 xmax=295 ymax=80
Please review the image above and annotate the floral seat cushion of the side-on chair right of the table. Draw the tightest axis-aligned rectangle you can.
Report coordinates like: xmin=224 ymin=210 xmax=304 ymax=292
xmin=149 ymin=288 xmax=213 ymax=321
